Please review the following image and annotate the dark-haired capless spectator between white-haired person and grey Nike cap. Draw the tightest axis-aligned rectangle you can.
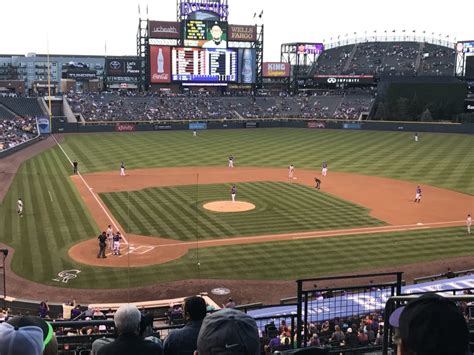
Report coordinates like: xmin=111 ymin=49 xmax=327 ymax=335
xmin=163 ymin=296 xmax=206 ymax=355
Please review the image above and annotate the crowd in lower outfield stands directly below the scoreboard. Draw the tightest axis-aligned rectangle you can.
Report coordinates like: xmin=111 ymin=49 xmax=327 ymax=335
xmin=68 ymin=89 xmax=373 ymax=121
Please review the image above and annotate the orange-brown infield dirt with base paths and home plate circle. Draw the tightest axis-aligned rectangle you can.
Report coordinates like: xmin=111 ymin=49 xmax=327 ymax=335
xmin=69 ymin=167 xmax=474 ymax=267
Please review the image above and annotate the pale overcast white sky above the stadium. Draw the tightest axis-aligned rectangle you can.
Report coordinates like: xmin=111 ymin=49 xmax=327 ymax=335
xmin=0 ymin=0 xmax=474 ymax=61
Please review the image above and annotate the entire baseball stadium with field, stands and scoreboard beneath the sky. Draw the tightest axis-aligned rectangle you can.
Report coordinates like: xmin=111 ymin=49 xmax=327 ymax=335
xmin=0 ymin=0 xmax=474 ymax=355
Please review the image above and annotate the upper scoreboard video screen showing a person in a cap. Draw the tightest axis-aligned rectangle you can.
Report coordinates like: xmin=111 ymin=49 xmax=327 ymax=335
xmin=184 ymin=20 xmax=227 ymax=48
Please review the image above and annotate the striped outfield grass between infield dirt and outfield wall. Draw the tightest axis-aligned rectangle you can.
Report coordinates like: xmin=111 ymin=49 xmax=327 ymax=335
xmin=64 ymin=128 xmax=474 ymax=195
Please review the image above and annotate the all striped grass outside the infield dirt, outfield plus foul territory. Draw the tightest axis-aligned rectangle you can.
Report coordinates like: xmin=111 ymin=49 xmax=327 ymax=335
xmin=0 ymin=129 xmax=474 ymax=288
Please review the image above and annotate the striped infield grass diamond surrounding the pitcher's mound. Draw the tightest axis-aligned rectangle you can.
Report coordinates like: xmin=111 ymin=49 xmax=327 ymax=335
xmin=101 ymin=182 xmax=383 ymax=241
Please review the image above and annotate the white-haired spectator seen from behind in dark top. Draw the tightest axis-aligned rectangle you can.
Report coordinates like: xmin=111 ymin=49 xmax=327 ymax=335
xmin=97 ymin=305 xmax=163 ymax=355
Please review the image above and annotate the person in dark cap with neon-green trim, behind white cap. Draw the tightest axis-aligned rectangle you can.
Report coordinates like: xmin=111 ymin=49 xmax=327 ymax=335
xmin=6 ymin=316 xmax=58 ymax=355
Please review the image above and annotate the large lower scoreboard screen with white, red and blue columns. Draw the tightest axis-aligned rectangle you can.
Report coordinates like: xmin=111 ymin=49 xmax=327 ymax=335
xmin=171 ymin=48 xmax=238 ymax=82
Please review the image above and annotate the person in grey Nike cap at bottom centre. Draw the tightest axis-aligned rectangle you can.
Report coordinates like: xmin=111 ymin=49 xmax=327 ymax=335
xmin=197 ymin=308 xmax=260 ymax=355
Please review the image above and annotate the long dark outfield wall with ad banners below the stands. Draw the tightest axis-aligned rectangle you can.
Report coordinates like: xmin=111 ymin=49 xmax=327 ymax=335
xmin=53 ymin=119 xmax=474 ymax=134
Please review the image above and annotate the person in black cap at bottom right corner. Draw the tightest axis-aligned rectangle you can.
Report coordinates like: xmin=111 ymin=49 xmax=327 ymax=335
xmin=389 ymin=293 xmax=469 ymax=355
